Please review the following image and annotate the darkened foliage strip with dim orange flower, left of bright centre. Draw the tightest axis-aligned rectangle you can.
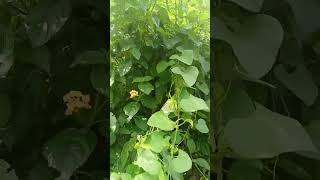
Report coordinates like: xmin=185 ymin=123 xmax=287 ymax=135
xmin=0 ymin=0 xmax=108 ymax=180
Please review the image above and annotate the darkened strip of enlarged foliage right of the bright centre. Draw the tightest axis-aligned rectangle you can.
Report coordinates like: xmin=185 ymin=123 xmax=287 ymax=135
xmin=211 ymin=0 xmax=320 ymax=180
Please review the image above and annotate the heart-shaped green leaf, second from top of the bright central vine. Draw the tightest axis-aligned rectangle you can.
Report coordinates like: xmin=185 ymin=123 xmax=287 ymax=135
xmin=171 ymin=66 xmax=199 ymax=87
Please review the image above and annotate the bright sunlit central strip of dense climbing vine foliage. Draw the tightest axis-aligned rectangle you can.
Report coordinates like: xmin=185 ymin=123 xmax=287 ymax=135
xmin=110 ymin=0 xmax=210 ymax=180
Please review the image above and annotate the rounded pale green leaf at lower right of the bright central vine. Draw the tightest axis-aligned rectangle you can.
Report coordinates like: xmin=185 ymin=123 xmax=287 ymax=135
xmin=171 ymin=149 xmax=192 ymax=173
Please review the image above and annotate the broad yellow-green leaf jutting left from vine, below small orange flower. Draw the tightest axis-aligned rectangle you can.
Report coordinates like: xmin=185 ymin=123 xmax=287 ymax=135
xmin=148 ymin=111 xmax=176 ymax=131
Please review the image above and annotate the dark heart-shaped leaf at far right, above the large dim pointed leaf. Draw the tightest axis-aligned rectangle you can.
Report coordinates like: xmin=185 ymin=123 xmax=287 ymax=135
xmin=274 ymin=64 xmax=318 ymax=106
